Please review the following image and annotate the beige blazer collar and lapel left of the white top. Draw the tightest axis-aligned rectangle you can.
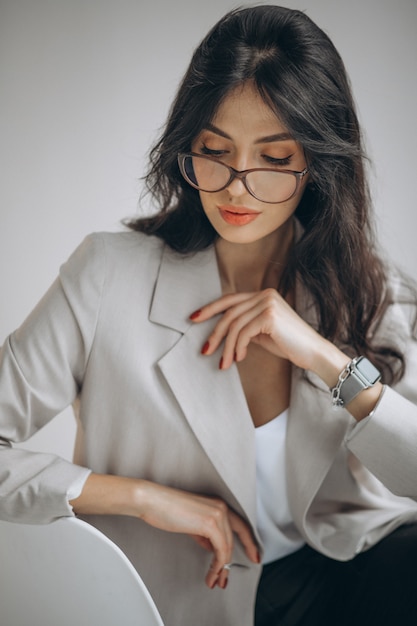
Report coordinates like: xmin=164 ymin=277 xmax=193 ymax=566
xmin=150 ymin=247 xmax=256 ymax=527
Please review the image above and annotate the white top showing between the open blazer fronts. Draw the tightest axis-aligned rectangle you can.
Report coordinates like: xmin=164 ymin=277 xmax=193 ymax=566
xmin=255 ymin=410 xmax=304 ymax=564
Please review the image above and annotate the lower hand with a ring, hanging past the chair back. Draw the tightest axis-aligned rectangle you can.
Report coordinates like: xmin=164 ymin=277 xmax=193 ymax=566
xmin=139 ymin=481 xmax=260 ymax=589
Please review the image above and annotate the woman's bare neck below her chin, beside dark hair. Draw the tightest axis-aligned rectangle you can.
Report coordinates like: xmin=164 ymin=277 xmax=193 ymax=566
xmin=216 ymin=220 xmax=294 ymax=293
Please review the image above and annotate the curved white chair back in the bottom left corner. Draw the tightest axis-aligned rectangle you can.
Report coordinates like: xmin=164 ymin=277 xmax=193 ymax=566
xmin=0 ymin=518 xmax=163 ymax=626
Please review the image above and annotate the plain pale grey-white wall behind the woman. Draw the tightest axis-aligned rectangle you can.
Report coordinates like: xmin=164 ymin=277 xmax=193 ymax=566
xmin=0 ymin=0 xmax=417 ymax=457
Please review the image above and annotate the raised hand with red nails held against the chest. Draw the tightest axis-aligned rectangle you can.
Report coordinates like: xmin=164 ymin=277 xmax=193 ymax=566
xmin=190 ymin=289 xmax=328 ymax=369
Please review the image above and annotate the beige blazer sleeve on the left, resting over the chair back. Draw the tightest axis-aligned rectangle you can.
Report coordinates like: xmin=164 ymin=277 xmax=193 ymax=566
xmin=0 ymin=235 xmax=105 ymax=523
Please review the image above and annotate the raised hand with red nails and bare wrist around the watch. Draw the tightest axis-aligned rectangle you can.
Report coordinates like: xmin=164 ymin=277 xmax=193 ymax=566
xmin=190 ymin=288 xmax=382 ymax=421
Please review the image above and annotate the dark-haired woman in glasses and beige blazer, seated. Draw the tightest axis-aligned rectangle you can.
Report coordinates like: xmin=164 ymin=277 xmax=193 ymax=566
xmin=0 ymin=6 xmax=417 ymax=626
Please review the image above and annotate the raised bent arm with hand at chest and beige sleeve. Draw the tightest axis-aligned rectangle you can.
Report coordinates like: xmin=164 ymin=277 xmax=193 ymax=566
xmin=191 ymin=289 xmax=417 ymax=498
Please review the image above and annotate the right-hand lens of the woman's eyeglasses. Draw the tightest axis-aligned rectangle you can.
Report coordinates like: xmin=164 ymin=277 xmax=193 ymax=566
xmin=246 ymin=170 xmax=297 ymax=203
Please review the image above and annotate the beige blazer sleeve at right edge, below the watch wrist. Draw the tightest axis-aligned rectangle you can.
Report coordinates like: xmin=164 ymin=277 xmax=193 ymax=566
xmin=347 ymin=304 xmax=417 ymax=500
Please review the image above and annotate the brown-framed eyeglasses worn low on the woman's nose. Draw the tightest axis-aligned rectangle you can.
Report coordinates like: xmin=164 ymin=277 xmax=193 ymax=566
xmin=178 ymin=152 xmax=308 ymax=204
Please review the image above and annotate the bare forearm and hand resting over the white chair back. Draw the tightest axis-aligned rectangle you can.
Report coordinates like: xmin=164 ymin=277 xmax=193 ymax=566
xmin=70 ymin=474 xmax=260 ymax=589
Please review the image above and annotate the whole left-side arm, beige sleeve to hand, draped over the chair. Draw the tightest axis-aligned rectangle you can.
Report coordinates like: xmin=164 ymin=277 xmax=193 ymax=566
xmin=0 ymin=237 xmax=258 ymax=587
